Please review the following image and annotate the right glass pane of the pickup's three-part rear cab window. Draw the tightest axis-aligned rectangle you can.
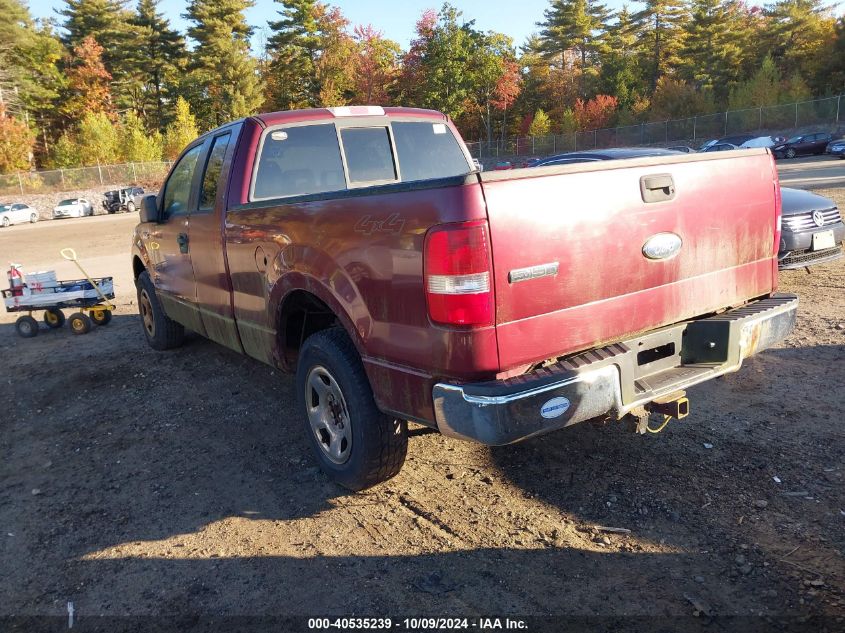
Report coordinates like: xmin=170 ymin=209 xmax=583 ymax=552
xmin=393 ymin=121 xmax=471 ymax=182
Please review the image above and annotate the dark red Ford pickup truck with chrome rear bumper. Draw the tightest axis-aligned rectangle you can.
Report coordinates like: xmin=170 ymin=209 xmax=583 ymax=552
xmin=132 ymin=106 xmax=798 ymax=489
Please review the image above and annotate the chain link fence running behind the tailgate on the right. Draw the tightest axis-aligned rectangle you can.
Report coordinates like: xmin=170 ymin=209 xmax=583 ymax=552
xmin=467 ymin=95 xmax=845 ymax=159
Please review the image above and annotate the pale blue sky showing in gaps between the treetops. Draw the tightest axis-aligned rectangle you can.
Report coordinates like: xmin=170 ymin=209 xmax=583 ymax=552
xmin=29 ymin=0 xmax=636 ymax=48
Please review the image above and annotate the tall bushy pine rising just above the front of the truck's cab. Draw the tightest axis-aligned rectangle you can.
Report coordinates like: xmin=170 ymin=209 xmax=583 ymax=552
xmin=184 ymin=0 xmax=262 ymax=128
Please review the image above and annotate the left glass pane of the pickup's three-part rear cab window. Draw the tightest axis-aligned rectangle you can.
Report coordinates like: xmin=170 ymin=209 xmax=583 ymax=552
xmin=252 ymin=123 xmax=346 ymax=200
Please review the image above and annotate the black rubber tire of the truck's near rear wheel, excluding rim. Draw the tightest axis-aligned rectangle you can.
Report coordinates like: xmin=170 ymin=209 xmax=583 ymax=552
xmin=296 ymin=328 xmax=408 ymax=491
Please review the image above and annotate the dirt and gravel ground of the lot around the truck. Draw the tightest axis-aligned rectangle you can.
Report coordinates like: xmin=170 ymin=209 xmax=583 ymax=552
xmin=0 ymin=190 xmax=845 ymax=630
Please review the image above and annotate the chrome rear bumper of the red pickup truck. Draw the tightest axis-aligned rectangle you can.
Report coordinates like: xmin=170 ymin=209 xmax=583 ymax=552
xmin=433 ymin=295 xmax=798 ymax=445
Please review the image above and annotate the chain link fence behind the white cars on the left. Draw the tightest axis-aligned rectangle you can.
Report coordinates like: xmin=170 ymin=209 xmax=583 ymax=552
xmin=0 ymin=161 xmax=172 ymax=196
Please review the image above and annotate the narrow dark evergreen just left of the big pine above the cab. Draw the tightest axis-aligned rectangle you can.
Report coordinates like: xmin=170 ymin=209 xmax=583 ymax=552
xmin=133 ymin=0 xmax=187 ymax=130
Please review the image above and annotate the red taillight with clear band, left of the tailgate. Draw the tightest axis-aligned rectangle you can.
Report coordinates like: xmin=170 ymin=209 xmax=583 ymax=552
xmin=423 ymin=222 xmax=494 ymax=326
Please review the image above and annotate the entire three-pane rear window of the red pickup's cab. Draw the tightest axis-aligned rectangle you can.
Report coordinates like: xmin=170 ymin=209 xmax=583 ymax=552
xmin=250 ymin=118 xmax=474 ymax=201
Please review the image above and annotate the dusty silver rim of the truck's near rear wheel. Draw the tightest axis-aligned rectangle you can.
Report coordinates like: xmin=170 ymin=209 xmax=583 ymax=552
xmin=305 ymin=365 xmax=352 ymax=464
